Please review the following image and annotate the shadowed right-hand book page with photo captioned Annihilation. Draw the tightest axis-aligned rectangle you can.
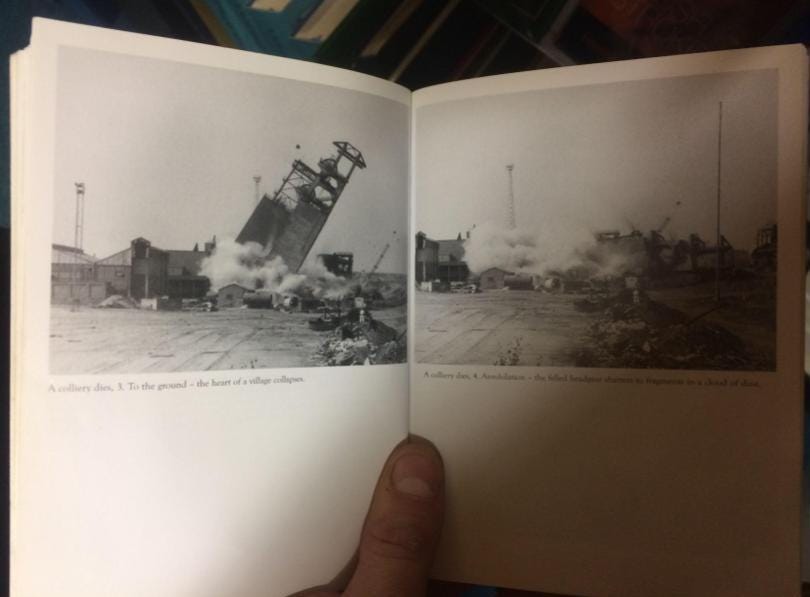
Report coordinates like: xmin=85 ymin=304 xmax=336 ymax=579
xmin=411 ymin=46 xmax=807 ymax=597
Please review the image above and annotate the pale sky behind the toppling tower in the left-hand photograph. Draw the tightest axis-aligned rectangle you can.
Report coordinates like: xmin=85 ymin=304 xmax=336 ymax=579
xmin=53 ymin=47 xmax=408 ymax=273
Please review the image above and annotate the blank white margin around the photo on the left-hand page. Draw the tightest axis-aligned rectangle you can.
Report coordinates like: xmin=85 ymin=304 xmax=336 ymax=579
xmin=12 ymin=19 xmax=410 ymax=597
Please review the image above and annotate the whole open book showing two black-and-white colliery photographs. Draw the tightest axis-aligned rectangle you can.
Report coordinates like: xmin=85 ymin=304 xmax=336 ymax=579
xmin=11 ymin=20 xmax=807 ymax=597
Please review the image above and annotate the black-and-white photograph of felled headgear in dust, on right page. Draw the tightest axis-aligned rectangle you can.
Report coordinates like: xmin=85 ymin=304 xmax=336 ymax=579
xmin=414 ymin=70 xmax=778 ymax=371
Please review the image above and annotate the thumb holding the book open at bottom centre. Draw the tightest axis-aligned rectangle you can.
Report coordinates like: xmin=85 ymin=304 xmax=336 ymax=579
xmin=344 ymin=437 xmax=444 ymax=597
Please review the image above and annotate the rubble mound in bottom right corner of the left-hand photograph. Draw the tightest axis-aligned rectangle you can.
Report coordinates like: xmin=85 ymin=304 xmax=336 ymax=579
xmin=318 ymin=320 xmax=407 ymax=366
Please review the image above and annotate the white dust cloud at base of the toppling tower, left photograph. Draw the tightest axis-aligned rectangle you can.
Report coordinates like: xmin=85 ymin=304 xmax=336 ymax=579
xmin=201 ymin=239 xmax=350 ymax=298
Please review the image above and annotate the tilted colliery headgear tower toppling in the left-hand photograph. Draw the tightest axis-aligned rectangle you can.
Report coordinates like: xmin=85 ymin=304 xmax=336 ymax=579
xmin=236 ymin=141 xmax=366 ymax=272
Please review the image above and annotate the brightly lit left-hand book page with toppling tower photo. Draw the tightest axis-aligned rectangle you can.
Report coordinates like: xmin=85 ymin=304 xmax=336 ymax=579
xmin=12 ymin=20 xmax=410 ymax=597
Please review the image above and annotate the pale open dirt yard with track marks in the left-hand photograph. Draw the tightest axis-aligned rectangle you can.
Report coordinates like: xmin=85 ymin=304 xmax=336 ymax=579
xmin=50 ymin=306 xmax=405 ymax=374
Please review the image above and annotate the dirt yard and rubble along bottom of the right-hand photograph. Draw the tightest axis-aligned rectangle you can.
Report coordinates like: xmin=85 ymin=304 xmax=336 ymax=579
xmin=415 ymin=277 xmax=776 ymax=371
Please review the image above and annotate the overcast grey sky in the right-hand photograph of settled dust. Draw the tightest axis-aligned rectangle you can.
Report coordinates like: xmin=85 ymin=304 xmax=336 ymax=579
xmin=415 ymin=71 xmax=777 ymax=249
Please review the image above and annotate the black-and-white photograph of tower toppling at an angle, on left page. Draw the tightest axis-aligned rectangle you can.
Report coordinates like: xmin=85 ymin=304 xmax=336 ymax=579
xmin=43 ymin=48 xmax=409 ymax=374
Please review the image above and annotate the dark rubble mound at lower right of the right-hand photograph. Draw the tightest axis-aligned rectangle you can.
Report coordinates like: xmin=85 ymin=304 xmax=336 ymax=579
xmin=574 ymin=293 xmax=762 ymax=370
